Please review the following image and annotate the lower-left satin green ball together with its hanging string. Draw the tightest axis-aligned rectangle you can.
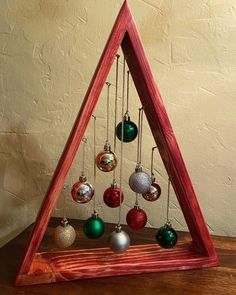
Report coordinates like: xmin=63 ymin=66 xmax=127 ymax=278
xmin=83 ymin=116 xmax=105 ymax=239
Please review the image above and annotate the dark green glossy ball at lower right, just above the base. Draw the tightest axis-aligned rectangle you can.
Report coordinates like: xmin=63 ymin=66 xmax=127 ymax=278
xmin=156 ymin=222 xmax=178 ymax=249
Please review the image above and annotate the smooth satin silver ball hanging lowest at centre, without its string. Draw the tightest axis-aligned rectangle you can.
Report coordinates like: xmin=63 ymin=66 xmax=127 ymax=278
xmin=108 ymin=225 xmax=130 ymax=254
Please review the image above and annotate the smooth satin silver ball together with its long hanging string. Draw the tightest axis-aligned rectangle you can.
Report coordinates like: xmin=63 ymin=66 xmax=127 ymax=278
xmin=108 ymin=57 xmax=130 ymax=254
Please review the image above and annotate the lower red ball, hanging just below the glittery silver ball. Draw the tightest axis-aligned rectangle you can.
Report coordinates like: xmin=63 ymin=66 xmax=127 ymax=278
xmin=126 ymin=205 xmax=147 ymax=230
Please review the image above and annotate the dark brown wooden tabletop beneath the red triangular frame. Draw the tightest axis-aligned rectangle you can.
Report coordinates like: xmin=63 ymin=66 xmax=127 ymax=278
xmin=0 ymin=218 xmax=236 ymax=295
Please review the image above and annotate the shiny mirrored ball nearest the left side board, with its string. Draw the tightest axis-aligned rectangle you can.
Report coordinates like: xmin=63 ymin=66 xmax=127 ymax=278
xmin=71 ymin=138 xmax=94 ymax=204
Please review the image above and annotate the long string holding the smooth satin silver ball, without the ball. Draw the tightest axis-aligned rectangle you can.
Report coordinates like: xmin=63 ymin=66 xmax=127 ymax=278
xmin=118 ymin=56 xmax=125 ymax=226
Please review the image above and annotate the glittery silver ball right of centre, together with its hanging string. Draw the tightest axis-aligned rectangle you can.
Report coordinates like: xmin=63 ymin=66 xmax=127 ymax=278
xmin=129 ymin=108 xmax=151 ymax=194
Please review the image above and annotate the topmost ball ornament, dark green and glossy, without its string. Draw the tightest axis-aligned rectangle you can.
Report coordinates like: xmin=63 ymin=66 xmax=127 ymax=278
xmin=116 ymin=114 xmax=138 ymax=142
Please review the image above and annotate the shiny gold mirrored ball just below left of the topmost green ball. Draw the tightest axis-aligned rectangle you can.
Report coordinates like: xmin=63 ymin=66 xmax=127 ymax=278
xmin=96 ymin=142 xmax=117 ymax=172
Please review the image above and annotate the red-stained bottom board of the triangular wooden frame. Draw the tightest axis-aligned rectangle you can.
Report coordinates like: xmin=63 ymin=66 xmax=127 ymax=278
xmin=15 ymin=243 xmax=218 ymax=286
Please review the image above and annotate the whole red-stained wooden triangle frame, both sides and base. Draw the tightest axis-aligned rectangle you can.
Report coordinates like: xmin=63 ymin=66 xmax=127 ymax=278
xmin=15 ymin=1 xmax=218 ymax=286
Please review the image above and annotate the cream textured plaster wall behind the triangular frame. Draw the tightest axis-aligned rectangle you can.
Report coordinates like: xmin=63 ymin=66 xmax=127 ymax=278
xmin=0 ymin=0 xmax=236 ymax=249
